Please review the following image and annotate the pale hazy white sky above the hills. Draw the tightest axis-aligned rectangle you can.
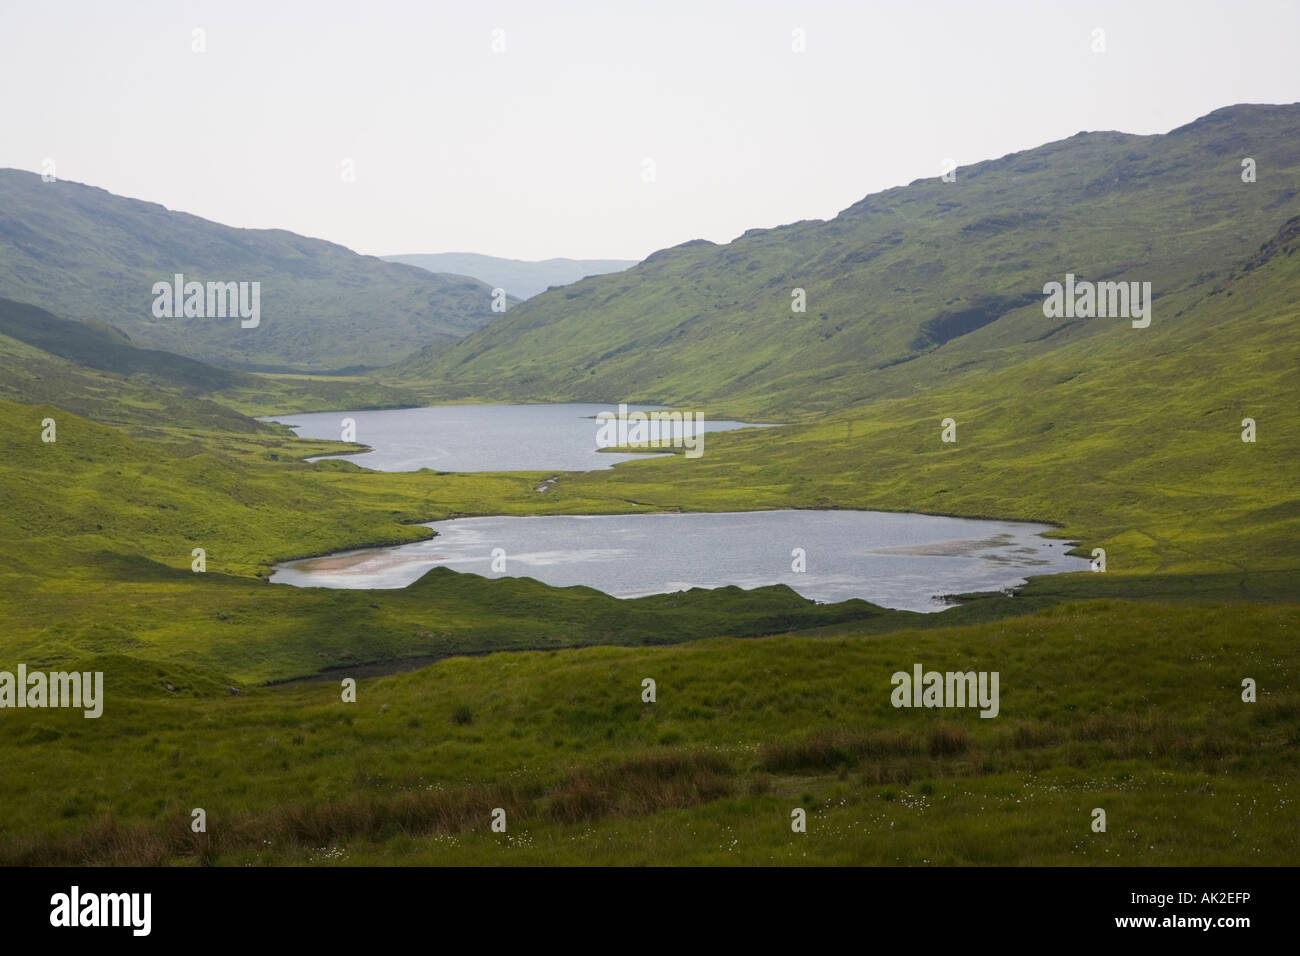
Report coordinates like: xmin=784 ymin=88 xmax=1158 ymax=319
xmin=0 ymin=0 xmax=1300 ymax=259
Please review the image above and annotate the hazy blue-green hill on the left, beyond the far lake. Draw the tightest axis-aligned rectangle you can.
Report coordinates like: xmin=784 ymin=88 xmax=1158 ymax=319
xmin=0 ymin=169 xmax=512 ymax=371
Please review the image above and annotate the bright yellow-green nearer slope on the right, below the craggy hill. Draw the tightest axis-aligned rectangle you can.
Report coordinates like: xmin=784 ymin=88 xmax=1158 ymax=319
xmin=558 ymin=217 xmax=1300 ymax=574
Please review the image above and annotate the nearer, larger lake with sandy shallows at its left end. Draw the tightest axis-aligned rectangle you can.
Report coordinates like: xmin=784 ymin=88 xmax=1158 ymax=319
xmin=270 ymin=511 xmax=1089 ymax=611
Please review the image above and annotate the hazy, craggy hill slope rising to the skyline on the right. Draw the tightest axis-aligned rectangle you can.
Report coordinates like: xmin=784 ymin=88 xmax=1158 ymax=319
xmin=394 ymin=105 xmax=1300 ymax=421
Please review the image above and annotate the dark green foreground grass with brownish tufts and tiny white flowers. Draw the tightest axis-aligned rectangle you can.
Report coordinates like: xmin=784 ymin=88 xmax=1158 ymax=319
xmin=0 ymin=601 xmax=1300 ymax=865
